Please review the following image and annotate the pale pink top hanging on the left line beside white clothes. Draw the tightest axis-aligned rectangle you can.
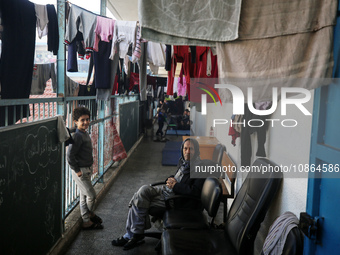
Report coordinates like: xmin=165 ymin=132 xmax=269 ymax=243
xmin=93 ymin=16 xmax=115 ymax=51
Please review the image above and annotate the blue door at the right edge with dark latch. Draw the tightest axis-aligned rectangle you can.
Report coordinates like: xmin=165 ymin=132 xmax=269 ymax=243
xmin=304 ymin=4 xmax=340 ymax=252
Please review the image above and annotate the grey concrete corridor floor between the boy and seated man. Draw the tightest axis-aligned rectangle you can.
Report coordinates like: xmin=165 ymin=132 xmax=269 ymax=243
xmin=66 ymin=136 xmax=182 ymax=255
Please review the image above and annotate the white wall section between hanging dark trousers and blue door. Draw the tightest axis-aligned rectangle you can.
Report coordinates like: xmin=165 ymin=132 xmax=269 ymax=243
xmin=255 ymin=91 xmax=314 ymax=254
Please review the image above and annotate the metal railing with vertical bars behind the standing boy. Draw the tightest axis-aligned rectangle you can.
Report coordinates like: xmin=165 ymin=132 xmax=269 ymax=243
xmin=0 ymin=95 xmax=138 ymax=219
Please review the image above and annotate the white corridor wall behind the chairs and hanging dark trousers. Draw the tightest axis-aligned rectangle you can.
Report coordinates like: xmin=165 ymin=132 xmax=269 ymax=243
xmin=191 ymin=94 xmax=313 ymax=254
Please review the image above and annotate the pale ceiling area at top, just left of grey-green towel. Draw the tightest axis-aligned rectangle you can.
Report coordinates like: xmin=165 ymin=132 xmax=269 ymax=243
xmin=106 ymin=0 xmax=138 ymax=21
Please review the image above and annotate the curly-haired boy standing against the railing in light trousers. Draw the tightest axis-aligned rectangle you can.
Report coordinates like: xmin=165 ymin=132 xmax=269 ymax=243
xmin=67 ymin=107 xmax=103 ymax=230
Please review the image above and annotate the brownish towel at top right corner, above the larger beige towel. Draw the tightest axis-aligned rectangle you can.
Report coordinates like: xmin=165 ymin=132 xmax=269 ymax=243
xmin=239 ymin=0 xmax=337 ymax=40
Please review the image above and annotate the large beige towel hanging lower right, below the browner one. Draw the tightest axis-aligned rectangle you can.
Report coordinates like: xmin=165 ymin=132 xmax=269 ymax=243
xmin=217 ymin=26 xmax=333 ymax=102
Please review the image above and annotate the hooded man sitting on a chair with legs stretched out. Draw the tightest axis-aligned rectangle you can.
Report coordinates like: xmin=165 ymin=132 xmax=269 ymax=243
xmin=112 ymin=138 xmax=204 ymax=250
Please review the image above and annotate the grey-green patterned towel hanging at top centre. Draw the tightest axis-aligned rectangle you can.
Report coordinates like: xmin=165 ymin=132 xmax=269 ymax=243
xmin=138 ymin=0 xmax=242 ymax=46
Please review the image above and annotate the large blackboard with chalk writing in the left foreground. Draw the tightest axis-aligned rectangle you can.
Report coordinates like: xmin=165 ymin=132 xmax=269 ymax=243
xmin=0 ymin=118 xmax=62 ymax=255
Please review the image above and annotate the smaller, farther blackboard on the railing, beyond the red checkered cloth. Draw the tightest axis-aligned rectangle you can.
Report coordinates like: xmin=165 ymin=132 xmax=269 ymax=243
xmin=119 ymin=101 xmax=139 ymax=152
